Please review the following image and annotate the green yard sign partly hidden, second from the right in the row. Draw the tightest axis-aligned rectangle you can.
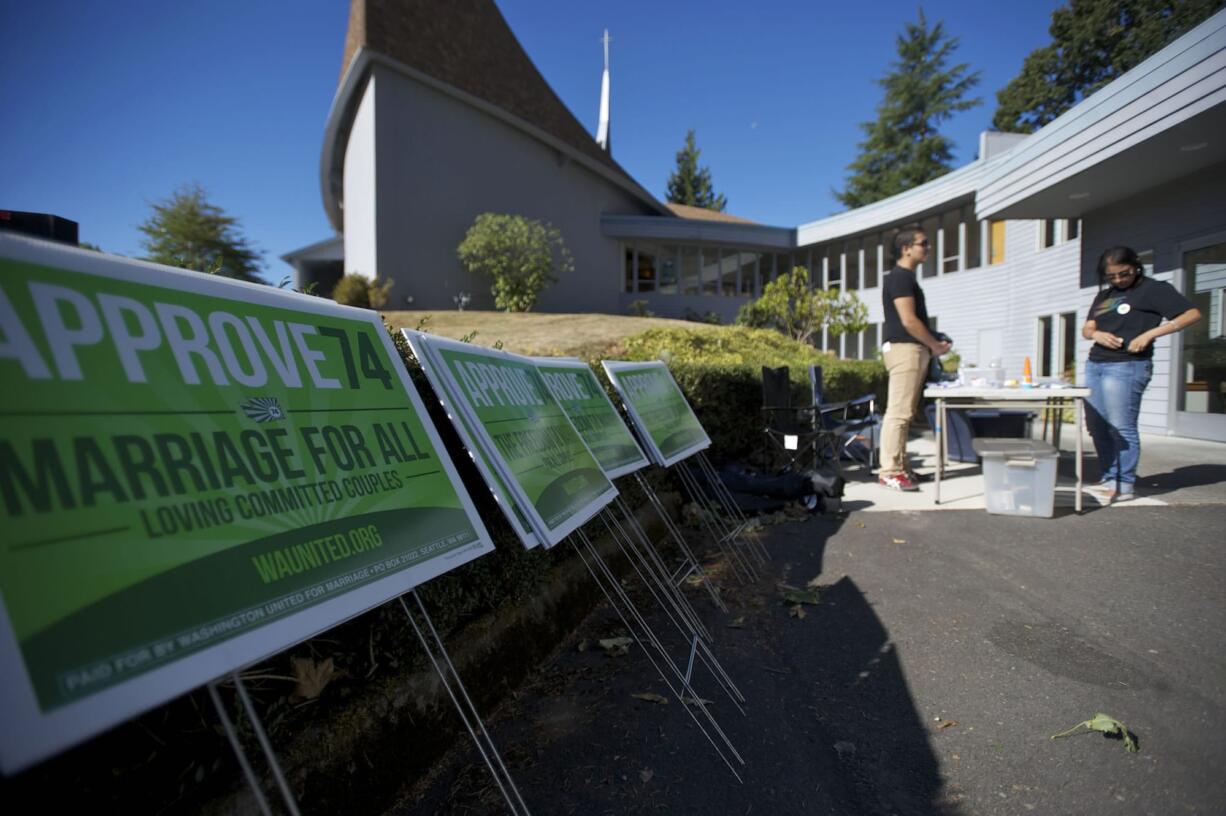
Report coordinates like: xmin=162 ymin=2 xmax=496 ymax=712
xmin=533 ymin=357 xmax=650 ymax=479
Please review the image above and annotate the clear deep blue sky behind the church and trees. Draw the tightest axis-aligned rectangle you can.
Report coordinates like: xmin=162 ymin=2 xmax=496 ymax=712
xmin=0 ymin=0 xmax=1062 ymax=282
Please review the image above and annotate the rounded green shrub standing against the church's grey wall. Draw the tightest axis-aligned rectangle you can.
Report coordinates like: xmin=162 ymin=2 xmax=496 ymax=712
xmin=456 ymin=212 xmax=575 ymax=311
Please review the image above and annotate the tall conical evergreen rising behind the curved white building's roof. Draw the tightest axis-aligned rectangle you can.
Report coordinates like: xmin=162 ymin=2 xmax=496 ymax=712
xmin=834 ymin=9 xmax=980 ymax=208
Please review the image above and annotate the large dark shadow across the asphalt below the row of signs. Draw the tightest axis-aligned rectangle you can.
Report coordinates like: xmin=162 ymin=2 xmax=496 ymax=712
xmin=392 ymin=517 xmax=956 ymax=816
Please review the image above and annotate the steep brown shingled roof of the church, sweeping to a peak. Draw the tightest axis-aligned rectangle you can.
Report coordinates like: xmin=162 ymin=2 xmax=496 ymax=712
xmin=341 ymin=0 xmax=658 ymax=206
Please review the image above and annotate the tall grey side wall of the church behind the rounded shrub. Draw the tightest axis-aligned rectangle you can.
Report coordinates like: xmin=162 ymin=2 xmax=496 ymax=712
xmin=357 ymin=65 xmax=647 ymax=314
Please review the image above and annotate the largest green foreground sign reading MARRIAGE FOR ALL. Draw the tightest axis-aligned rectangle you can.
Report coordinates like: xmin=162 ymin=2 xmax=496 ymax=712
xmin=0 ymin=234 xmax=493 ymax=772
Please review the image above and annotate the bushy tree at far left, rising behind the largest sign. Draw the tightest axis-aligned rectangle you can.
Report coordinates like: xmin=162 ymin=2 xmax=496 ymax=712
xmin=137 ymin=184 xmax=262 ymax=283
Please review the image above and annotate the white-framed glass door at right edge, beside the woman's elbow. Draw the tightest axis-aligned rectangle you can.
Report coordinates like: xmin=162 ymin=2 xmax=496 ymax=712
xmin=1176 ymin=244 xmax=1226 ymax=441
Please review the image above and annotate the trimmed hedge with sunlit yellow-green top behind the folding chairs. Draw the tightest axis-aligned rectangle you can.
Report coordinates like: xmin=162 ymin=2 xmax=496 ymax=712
xmin=609 ymin=326 xmax=886 ymax=461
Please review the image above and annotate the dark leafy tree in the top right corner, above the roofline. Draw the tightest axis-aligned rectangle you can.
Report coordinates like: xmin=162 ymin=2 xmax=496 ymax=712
xmin=992 ymin=0 xmax=1226 ymax=134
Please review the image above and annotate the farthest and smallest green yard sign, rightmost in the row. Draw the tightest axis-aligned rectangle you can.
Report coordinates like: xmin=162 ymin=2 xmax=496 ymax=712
xmin=601 ymin=360 xmax=711 ymax=468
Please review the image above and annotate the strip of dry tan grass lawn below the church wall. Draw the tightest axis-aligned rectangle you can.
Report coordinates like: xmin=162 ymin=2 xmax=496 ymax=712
xmin=383 ymin=311 xmax=700 ymax=357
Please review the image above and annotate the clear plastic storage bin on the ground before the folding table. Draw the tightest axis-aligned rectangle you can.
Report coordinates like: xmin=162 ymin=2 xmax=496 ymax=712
xmin=973 ymin=439 xmax=1058 ymax=518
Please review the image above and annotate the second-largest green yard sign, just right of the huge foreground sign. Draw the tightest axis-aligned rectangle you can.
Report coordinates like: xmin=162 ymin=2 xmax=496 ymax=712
xmin=414 ymin=334 xmax=617 ymax=546
